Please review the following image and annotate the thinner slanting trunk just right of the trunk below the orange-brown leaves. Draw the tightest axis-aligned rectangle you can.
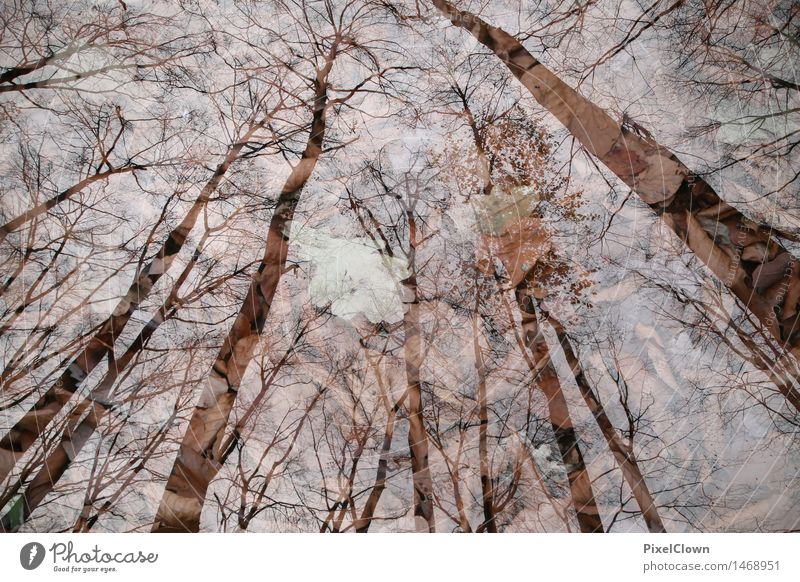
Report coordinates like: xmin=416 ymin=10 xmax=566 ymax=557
xmin=540 ymin=307 xmax=667 ymax=533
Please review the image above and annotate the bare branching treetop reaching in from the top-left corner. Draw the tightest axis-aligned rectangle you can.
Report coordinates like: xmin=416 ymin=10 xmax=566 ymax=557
xmin=0 ymin=0 xmax=211 ymax=93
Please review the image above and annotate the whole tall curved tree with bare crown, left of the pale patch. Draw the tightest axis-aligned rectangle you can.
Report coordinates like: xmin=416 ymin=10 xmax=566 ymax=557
xmin=153 ymin=2 xmax=406 ymax=532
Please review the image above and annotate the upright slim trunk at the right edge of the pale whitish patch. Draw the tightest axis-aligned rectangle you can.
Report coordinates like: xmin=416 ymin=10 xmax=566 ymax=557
xmin=401 ymin=210 xmax=436 ymax=532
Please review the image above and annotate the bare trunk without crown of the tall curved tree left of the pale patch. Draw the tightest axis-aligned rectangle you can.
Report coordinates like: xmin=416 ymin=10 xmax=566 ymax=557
xmin=152 ymin=54 xmax=336 ymax=533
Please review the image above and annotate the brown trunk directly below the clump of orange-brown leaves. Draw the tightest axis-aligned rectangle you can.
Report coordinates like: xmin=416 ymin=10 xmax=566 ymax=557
xmin=516 ymin=273 xmax=604 ymax=533
